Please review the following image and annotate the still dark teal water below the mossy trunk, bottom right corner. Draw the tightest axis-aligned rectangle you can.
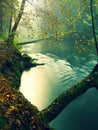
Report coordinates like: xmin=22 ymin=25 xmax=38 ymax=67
xmin=50 ymin=88 xmax=98 ymax=130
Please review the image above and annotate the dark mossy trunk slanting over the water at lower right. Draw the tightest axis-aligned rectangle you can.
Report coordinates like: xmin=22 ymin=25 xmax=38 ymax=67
xmin=41 ymin=65 xmax=98 ymax=123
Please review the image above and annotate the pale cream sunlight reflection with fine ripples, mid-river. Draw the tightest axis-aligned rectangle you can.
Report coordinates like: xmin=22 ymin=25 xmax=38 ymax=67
xmin=20 ymin=54 xmax=76 ymax=110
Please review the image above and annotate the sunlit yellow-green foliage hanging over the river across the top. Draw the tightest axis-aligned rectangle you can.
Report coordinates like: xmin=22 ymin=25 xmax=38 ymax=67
xmin=1 ymin=0 xmax=98 ymax=52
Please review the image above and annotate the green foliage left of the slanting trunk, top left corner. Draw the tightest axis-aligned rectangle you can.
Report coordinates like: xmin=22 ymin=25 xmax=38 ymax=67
xmin=0 ymin=0 xmax=19 ymax=40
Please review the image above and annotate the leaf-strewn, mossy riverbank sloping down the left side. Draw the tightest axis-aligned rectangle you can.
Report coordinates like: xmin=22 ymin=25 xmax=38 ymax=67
xmin=0 ymin=43 xmax=50 ymax=130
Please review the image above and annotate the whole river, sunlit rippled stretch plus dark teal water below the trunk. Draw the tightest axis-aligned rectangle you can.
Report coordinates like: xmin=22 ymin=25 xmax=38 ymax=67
xmin=20 ymin=42 xmax=98 ymax=130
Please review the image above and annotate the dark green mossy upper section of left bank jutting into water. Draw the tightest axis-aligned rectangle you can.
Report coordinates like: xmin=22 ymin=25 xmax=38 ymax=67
xmin=0 ymin=46 xmax=36 ymax=89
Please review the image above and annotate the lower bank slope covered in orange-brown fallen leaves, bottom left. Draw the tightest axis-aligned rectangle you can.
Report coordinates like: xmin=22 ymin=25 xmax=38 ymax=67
xmin=0 ymin=73 xmax=49 ymax=130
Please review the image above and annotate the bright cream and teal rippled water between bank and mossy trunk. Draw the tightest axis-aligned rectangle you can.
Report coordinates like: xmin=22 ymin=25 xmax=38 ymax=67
xmin=20 ymin=53 xmax=96 ymax=110
